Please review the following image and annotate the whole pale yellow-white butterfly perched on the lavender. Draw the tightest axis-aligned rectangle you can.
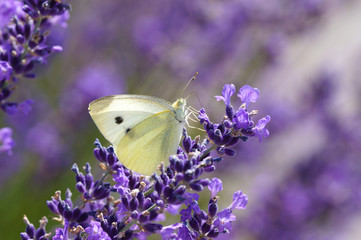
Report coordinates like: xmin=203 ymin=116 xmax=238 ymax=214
xmin=88 ymin=95 xmax=186 ymax=175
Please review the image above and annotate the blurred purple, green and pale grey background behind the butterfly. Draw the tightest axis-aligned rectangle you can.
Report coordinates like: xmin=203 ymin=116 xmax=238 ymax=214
xmin=0 ymin=0 xmax=361 ymax=240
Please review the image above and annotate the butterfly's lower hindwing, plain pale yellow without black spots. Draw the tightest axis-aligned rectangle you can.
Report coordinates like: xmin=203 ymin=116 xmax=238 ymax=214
xmin=114 ymin=111 xmax=184 ymax=175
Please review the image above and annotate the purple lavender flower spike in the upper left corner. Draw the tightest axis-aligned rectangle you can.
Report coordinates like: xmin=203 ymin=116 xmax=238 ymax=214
xmin=0 ymin=0 xmax=70 ymax=114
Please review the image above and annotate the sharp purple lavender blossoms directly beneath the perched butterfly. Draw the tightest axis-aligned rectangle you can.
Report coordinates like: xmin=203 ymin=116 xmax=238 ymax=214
xmin=21 ymin=84 xmax=269 ymax=240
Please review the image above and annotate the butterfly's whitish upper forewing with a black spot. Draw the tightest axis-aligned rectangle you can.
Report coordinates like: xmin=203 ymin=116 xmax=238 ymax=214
xmin=89 ymin=95 xmax=172 ymax=146
